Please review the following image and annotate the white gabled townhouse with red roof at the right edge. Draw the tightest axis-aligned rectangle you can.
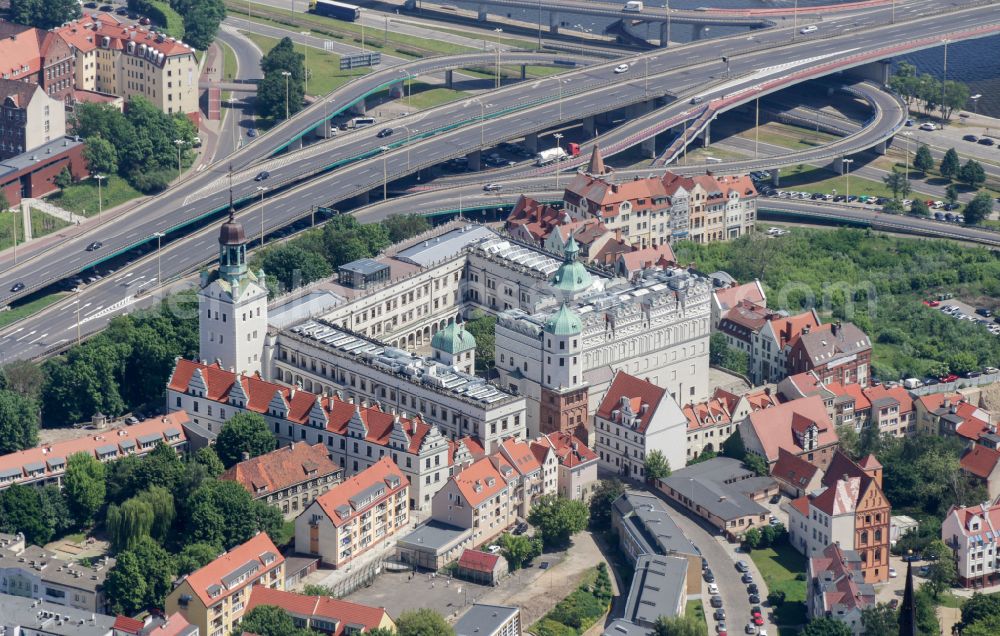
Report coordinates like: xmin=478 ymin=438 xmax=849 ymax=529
xmin=941 ymin=503 xmax=1000 ymax=587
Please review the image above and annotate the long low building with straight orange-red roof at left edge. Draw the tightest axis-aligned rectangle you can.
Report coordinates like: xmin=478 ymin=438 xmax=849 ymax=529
xmin=0 ymin=410 xmax=189 ymax=489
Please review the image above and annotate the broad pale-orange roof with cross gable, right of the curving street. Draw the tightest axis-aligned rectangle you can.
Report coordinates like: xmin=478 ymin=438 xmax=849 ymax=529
xmin=748 ymin=395 xmax=837 ymax=462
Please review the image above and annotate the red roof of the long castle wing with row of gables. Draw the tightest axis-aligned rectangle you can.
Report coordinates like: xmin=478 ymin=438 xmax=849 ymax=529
xmin=167 ymin=359 xmax=442 ymax=453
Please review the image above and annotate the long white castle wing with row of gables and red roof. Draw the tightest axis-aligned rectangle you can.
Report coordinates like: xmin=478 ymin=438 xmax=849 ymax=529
xmin=167 ymin=359 xmax=452 ymax=509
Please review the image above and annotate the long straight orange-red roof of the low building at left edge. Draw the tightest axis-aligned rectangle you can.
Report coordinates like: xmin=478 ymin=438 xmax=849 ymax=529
xmin=0 ymin=411 xmax=190 ymax=483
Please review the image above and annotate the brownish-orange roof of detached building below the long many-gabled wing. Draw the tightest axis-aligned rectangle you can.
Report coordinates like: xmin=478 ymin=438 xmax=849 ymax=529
xmin=220 ymin=442 xmax=340 ymax=496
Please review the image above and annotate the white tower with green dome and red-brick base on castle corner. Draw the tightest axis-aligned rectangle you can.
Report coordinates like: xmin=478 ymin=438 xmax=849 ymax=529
xmin=539 ymin=306 xmax=589 ymax=440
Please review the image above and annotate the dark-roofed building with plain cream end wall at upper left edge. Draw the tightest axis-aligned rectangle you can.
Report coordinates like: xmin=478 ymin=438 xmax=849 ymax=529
xmin=0 ymin=79 xmax=66 ymax=159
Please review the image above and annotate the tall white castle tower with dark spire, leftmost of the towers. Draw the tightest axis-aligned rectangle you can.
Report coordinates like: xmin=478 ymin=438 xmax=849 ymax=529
xmin=198 ymin=202 xmax=267 ymax=374
